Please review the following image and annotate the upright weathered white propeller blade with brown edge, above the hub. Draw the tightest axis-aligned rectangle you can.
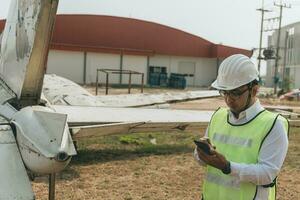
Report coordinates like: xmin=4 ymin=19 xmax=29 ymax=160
xmin=0 ymin=0 xmax=58 ymax=107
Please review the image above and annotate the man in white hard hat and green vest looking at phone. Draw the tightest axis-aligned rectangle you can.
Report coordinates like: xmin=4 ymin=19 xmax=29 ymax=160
xmin=194 ymin=54 xmax=288 ymax=200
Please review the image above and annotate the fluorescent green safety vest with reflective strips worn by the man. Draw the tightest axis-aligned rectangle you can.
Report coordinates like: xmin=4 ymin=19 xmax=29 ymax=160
xmin=203 ymin=108 xmax=288 ymax=200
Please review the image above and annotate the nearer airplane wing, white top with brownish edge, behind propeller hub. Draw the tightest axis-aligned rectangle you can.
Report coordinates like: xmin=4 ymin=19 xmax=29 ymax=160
xmin=51 ymin=105 xmax=213 ymax=139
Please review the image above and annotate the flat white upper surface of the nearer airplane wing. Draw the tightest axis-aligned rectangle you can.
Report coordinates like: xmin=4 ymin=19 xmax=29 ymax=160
xmin=51 ymin=105 xmax=213 ymax=126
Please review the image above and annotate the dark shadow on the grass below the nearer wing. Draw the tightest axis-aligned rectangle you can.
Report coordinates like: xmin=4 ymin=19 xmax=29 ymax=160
xmin=72 ymin=145 xmax=193 ymax=165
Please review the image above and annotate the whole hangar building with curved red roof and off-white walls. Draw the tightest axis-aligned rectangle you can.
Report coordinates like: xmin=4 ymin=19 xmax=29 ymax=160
xmin=0 ymin=15 xmax=252 ymax=87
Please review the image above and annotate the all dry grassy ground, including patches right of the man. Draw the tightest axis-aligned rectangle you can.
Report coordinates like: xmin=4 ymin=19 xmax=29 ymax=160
xmin=33 ymin=88 xmax=300 ymax=200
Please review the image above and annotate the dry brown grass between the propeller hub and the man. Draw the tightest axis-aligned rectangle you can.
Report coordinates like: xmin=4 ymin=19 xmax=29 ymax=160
xmin=33 ymin=133 xmax=206 ymax=200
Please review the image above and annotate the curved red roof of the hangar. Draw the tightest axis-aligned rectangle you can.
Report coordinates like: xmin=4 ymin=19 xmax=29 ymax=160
xmin=0 ymin=15 xmax=251 ymax=58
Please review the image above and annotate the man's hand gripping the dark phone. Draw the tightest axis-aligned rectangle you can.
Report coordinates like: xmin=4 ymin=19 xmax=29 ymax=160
xmin=197 ymin=140 xmax=228 ymax=170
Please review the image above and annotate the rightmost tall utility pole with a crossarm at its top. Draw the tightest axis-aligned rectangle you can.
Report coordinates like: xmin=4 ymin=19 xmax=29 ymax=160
xmin=274 ymin=1 xmax=291 ymax=94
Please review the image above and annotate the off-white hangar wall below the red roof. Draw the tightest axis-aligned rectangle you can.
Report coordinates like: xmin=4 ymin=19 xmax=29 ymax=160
xmin=47 ymin=50 xmax=217 ymax=87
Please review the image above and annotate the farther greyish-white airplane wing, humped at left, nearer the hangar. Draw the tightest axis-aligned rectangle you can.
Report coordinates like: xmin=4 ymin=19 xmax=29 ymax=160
xmin=43 ymin=74 xmax=219 ymax=108
